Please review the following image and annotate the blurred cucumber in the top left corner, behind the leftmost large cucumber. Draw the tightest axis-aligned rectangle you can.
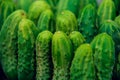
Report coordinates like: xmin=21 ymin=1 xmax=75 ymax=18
xmin=0 ymin=0 xmax=15 ymax=29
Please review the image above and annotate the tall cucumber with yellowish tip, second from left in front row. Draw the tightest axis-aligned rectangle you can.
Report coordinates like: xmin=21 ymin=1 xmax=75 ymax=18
xmin=18 ymin=19 xmax=38 ymax=80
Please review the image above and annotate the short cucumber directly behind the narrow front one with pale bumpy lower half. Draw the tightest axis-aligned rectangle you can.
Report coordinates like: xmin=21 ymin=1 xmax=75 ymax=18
xmin=37 ymin=9 xmax=55 ymax=32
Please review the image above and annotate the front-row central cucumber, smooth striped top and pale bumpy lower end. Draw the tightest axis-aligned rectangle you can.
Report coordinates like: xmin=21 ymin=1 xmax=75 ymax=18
xmin=52 ymin=31 xmax=73 ymax=80
